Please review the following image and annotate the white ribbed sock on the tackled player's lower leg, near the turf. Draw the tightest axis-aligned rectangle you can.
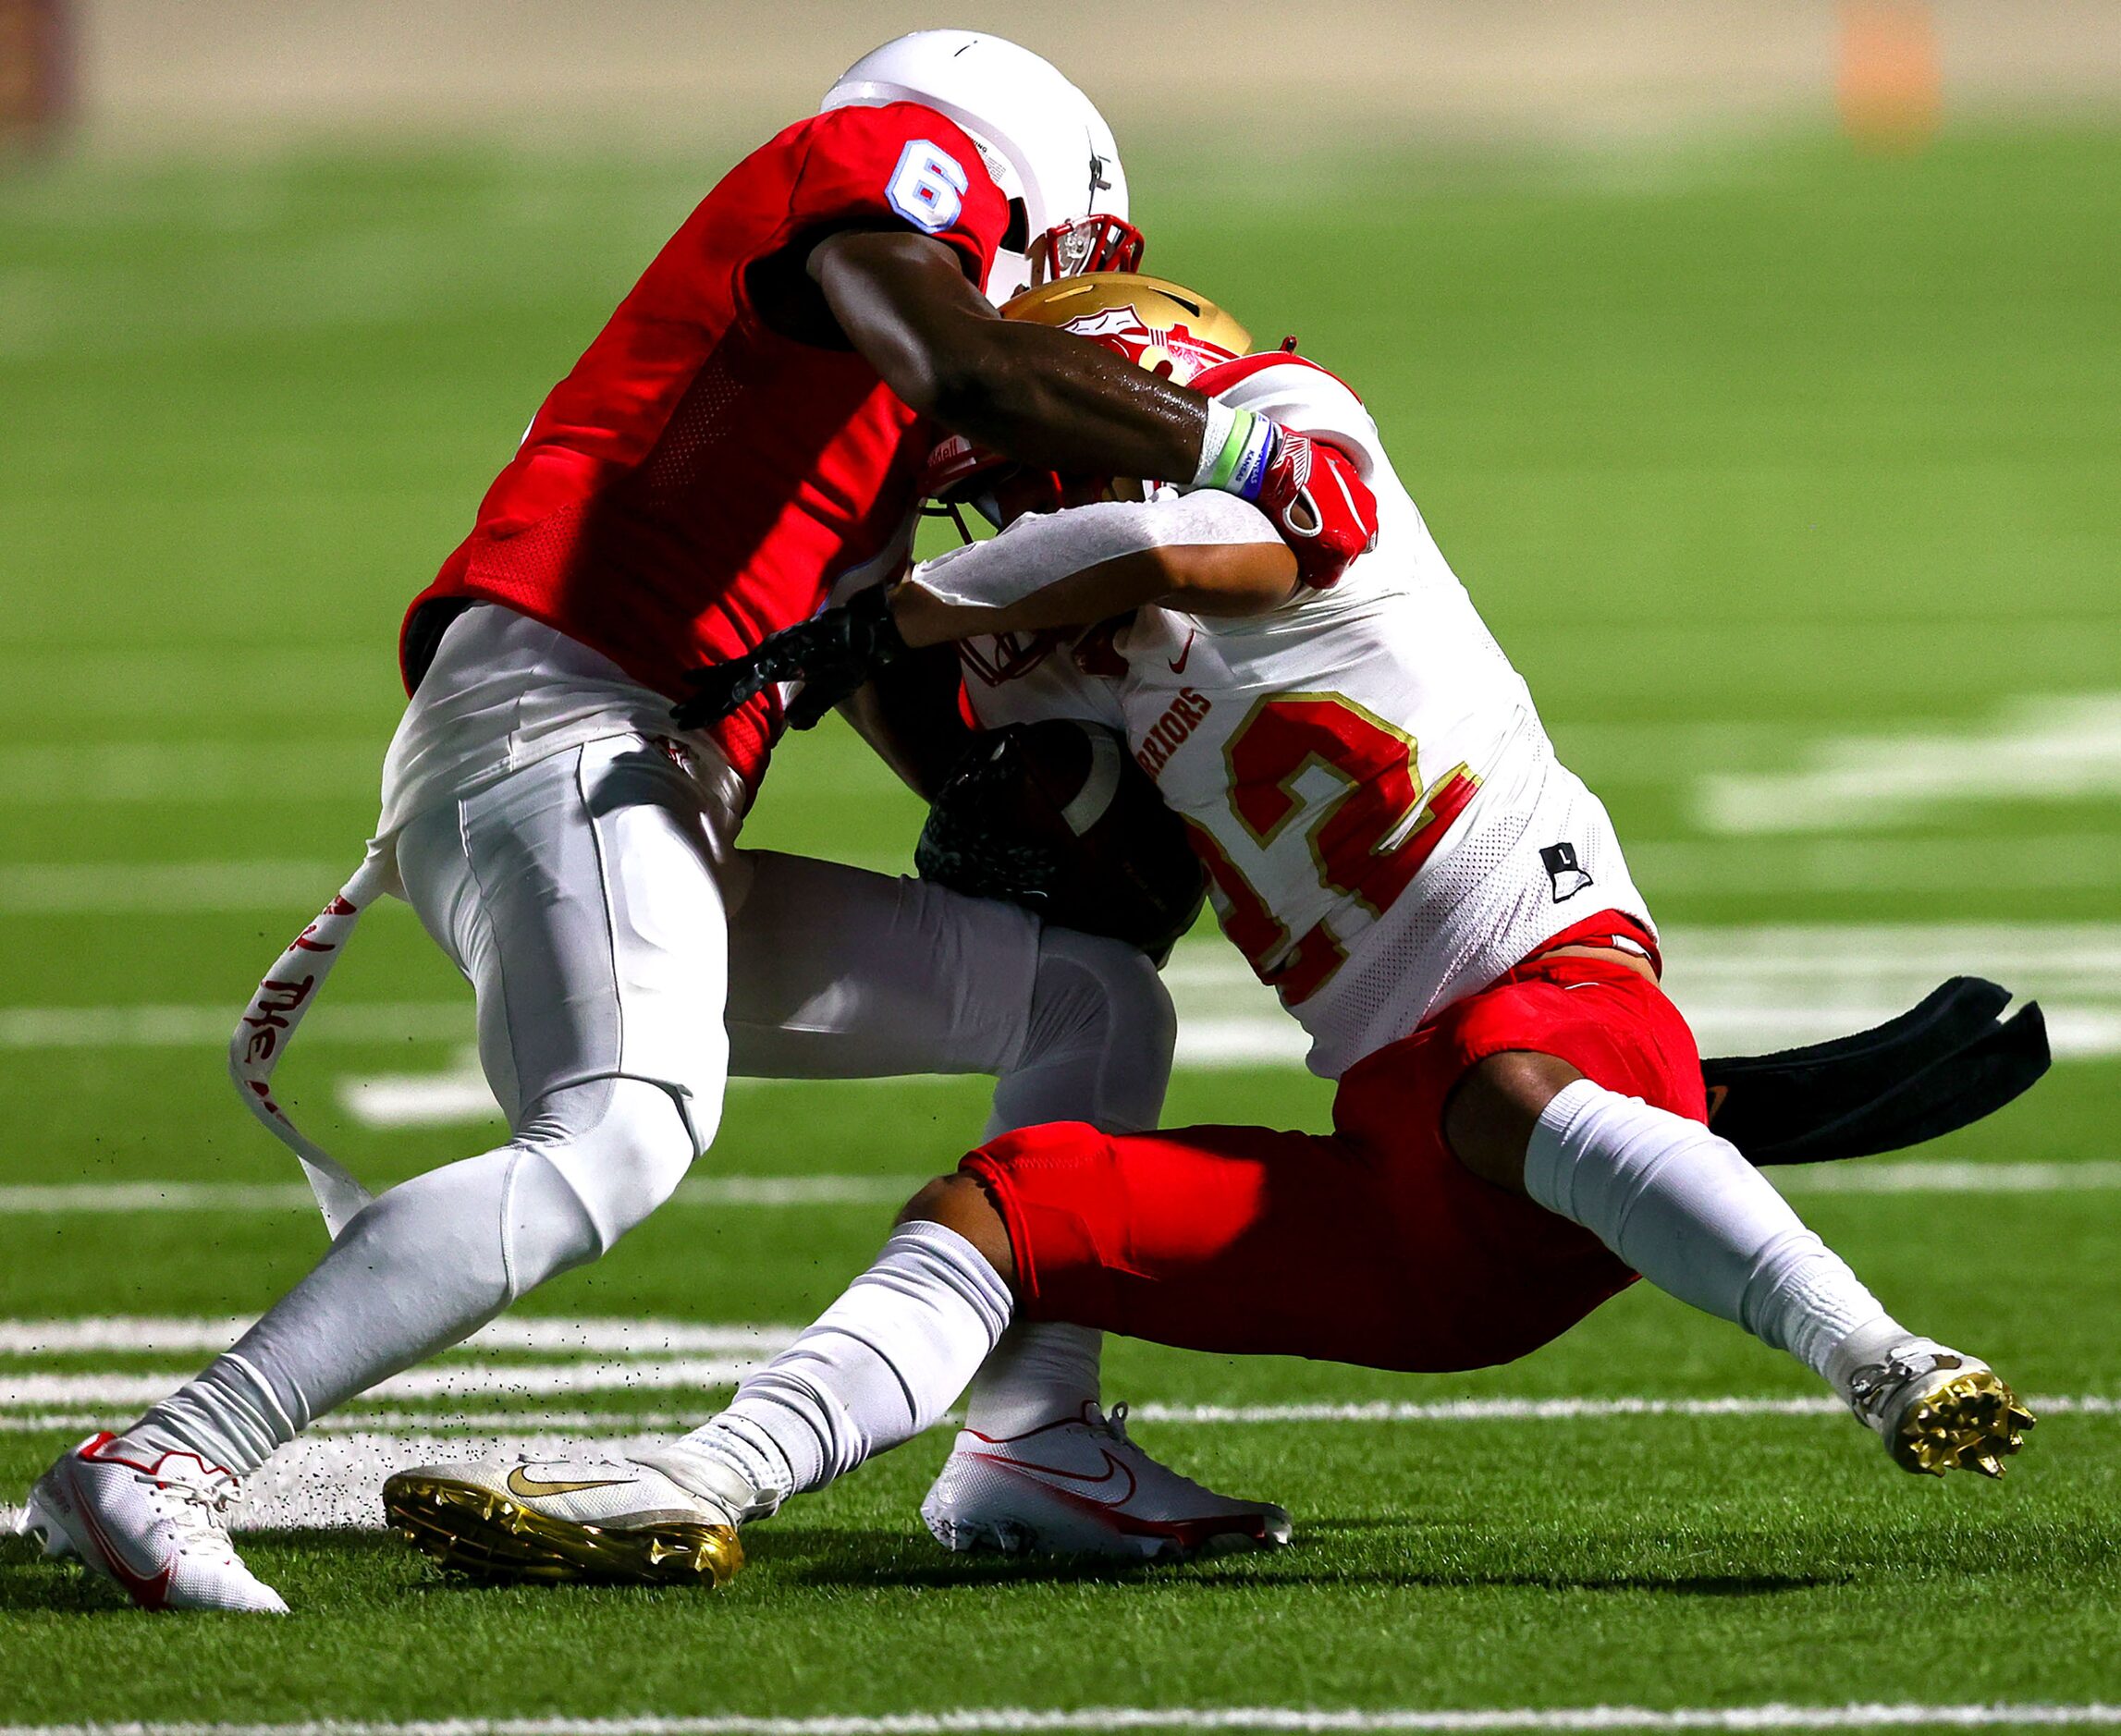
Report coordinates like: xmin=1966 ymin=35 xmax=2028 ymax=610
xmin=657 ymin=1223 xmax=1016 ymax=1511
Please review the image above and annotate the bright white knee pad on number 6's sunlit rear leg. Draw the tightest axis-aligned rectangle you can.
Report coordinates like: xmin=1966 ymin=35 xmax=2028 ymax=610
xmin=507 ymin=1079 xmax=693 ymax=1293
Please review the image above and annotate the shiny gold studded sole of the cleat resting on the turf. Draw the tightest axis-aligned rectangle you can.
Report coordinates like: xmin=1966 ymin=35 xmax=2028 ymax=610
xmin=384 ymin=1475 xmax=744 ymax=1590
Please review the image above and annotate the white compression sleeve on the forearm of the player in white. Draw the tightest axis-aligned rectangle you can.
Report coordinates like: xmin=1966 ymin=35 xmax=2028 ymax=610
xmin=910 ymin=490 xmax=1281 ymax=608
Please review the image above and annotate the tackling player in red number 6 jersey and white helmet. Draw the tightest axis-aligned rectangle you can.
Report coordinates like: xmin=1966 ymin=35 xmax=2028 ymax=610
xmin=28 ymin=31 xmax=1355 ymax=1611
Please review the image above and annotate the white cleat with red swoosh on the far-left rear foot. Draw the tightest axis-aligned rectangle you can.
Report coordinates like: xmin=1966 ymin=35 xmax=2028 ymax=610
xmin=17 ymin=1433 xmax=287 ymax=1615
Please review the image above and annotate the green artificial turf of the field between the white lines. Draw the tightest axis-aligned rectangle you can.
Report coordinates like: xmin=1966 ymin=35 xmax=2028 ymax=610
xmin=0 ymin=129 xmax=2121 ymax=1723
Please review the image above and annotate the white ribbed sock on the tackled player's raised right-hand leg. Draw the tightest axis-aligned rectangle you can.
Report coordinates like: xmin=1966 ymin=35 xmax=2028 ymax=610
xmin=1525 ymin=1079 xmax=1900 ymax=1380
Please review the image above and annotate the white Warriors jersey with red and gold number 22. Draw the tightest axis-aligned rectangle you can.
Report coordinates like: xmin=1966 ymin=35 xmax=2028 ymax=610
xmin=962 ymin=356 xmax=1650 ymax=1079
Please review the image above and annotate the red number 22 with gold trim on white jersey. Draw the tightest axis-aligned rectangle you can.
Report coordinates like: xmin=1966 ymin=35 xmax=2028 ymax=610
xmin=1188 ymin=693 xmax=1480 ymax=1007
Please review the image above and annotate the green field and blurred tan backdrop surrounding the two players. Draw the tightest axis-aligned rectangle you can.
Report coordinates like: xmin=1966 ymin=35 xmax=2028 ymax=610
xmin=0 ymin=0 xmax=2121 ymax=1736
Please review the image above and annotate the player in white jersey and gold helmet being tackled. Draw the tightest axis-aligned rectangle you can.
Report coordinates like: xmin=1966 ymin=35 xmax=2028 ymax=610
xmin=386 ymin=275 xmax=2029 ymax=1577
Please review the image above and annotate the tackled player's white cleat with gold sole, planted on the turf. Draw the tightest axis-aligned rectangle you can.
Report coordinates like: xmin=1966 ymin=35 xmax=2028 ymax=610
xmin=384 ymin=1459 xmax=766 ymax=1587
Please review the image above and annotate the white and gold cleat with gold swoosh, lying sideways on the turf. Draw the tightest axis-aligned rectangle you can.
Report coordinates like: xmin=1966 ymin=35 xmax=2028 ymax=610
xmin=384 ymin=1464 xmax=744 ymax=1587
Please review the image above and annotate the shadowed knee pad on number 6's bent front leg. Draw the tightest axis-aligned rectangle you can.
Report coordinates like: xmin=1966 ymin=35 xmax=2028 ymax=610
xmin=997 ymin=928 xmax=1177 ymax=1131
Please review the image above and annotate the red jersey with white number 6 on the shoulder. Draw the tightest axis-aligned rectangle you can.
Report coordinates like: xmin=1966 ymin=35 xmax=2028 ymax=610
xmin=411 ymin=102 xmax=1010 ymax=784
